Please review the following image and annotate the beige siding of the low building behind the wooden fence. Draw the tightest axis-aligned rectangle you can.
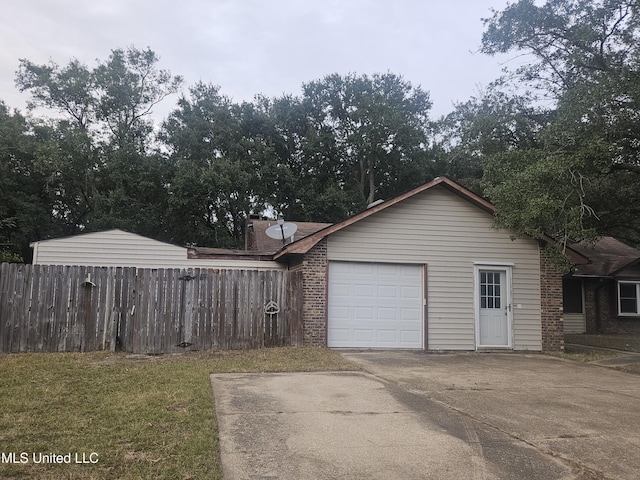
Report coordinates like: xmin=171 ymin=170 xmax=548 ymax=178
xmin=33 ymin=230 xmax=283 ymax=270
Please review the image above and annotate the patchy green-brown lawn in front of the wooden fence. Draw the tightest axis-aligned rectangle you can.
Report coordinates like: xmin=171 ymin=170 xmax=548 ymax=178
xmin=0 ymin=348 xmax=356 ymax=480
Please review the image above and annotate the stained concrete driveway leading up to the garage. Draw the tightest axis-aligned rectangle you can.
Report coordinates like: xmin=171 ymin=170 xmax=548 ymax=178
xmin=211 ymin=351 xmax=640 ymax=480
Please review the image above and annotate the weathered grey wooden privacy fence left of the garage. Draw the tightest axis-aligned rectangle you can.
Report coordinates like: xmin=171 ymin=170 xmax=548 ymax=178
xmin=0 ymin=263 xmax=302 ymax=354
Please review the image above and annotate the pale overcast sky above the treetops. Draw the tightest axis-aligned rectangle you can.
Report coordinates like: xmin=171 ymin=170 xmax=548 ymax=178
xmin=0 ymin=0 xmax=507 ymax=119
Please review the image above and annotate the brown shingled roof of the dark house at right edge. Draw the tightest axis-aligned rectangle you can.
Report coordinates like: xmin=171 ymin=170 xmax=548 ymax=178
xmin=571 ymin=237 xmax=640 ymax=277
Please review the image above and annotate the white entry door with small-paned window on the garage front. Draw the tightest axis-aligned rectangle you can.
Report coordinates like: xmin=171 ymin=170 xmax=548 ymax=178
xmin=476 ymin=267 xmax=511 ymax=347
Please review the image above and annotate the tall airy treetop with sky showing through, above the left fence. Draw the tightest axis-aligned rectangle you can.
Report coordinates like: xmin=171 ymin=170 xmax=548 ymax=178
xmin=16 ymin=47 xmax=182 ymax=148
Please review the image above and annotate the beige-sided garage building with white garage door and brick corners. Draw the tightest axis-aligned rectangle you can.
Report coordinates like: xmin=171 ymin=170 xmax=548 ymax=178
xmin=274 ymin=177 xmax=572 ymax=351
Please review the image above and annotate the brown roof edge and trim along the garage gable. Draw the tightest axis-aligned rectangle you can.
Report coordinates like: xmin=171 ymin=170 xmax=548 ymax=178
xmin=273 ymin=177 xmax=496 ymax=260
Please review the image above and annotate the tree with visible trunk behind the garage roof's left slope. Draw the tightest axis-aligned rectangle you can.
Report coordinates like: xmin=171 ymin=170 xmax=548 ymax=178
xmin=303 ymin=73 xmax=431 ymax=206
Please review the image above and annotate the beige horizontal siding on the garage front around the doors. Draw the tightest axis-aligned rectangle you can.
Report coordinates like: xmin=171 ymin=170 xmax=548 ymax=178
xmin=327 ymin=187 xmax=542 ymax=351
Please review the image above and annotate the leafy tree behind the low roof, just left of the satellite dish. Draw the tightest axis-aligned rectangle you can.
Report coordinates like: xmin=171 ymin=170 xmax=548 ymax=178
xmin=163 ymin=83 xmax=264 ymax=248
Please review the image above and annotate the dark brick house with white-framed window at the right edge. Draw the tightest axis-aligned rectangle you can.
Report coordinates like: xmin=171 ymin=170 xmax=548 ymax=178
xmin=563 ymin=237 xmax=640 ymax=334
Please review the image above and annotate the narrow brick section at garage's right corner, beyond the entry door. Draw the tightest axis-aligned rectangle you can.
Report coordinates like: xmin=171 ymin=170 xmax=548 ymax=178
xmin=540 ymin=246 xmax=564 ymax=352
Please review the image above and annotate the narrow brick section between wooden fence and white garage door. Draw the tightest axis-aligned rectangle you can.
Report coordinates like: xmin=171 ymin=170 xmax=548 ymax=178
xmin=296 ymin=238 xmax=327 ymax=347
